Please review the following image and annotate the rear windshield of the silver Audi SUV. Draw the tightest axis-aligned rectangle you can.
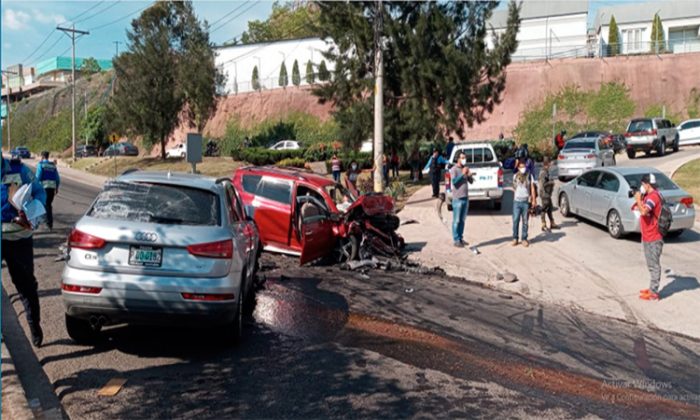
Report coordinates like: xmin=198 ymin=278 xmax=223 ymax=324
xmin=87 ymin=181 xmax=221 ymax=226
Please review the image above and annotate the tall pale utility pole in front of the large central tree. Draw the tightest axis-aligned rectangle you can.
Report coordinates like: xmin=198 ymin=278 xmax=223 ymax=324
xmin=374 ymin=0 xmax=384 ymax=193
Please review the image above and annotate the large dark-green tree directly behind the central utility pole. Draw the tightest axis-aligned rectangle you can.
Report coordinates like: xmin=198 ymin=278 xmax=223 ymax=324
xmin=314 ymin=2 xmax=520 ymax=150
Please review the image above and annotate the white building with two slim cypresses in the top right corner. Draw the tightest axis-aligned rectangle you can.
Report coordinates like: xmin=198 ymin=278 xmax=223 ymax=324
xmin=595 ymin=0 xmax=700 ymax=55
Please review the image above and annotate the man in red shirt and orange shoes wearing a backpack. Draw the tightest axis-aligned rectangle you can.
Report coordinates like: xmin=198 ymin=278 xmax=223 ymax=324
xmin=632 ymin=174 xmax=664 ymax=300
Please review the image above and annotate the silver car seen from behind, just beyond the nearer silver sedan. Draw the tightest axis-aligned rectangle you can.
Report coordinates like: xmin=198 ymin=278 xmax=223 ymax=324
xmin=557 ymin=136 xmax=617 ymax=182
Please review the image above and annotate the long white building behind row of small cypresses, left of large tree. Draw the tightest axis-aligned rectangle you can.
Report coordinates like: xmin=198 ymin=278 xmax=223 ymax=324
xmin=216 ymin=38 xmax=334 ymax=95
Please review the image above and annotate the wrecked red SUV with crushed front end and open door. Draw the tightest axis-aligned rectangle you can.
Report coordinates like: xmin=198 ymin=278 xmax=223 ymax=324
xmin=233 ymin=167 xmax=403 ymax=264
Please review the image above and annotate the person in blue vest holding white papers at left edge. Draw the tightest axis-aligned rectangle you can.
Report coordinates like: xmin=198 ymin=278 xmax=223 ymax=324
xmin=1 ymin=158 xmax=46 ymax=347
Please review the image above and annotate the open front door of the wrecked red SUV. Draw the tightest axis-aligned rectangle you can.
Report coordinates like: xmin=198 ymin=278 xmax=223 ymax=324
xmin=297 ymin=196 xmax=337 ymax=265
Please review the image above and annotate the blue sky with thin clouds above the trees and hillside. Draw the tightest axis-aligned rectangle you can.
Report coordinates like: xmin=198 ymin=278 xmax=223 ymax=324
xmin=1 ymin=0 xmax=652 ymax=68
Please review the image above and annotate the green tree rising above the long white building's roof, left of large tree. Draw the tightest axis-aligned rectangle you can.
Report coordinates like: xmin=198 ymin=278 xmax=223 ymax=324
xmin=241 ymin=2 xmax=319 ymax=44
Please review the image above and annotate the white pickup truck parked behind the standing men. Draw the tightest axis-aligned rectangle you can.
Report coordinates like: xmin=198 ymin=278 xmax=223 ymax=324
xmin=445 ymin=143 xmax=503 ymax=211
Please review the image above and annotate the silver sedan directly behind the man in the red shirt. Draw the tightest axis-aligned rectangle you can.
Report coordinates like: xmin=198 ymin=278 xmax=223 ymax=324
xmin=559 ymin=167 xmax=695 ymax=239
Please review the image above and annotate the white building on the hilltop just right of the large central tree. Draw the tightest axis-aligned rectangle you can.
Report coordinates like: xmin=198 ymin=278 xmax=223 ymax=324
xmin=487 ymin=0 xmax=593 ymax=61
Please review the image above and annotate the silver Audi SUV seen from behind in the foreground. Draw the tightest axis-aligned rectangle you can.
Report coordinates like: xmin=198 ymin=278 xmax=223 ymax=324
xmin=62 ymin=171 xmax=259 ymax=343
